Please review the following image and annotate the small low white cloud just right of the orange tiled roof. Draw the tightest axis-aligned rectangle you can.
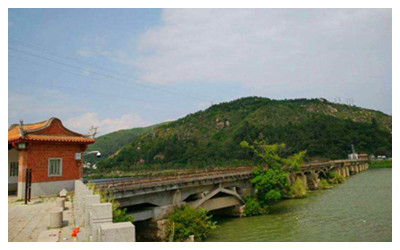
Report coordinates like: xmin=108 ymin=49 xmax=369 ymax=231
xmin=64 ymin=112 xmax=151 ymax=135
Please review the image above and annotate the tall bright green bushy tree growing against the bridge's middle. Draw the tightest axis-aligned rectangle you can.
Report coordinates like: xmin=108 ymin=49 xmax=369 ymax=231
xmin=241 ymin=141 xmax=306 ymax=216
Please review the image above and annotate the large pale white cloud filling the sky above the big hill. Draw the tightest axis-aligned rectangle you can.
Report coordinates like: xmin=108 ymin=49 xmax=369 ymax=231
xmin=134 ymin=9 xmax=392 ymax=112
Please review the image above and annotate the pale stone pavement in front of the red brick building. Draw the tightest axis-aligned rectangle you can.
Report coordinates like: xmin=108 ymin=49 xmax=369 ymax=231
xmin=8 ymin=196 xmax=75 ymax=242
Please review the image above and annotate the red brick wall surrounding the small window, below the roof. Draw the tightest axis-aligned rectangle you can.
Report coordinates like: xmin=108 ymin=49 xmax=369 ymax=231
xmin=18 ymin=142 xmax=84 ymax=182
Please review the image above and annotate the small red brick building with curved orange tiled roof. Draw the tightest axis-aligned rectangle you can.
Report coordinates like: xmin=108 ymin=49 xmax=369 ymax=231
xmin=8 ymin=118 xmax=94 ymax=198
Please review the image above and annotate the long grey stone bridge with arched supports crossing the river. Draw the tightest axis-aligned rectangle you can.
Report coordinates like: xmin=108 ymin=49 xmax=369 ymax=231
xmin=96 ymin=160 xmax=368 ymax=222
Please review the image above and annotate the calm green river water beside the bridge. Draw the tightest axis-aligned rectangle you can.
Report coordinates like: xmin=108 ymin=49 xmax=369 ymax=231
xmin=207 ymin=169 xmax=392 ymax=242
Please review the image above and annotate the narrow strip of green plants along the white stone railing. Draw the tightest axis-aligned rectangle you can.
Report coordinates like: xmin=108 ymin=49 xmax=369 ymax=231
xmin=87 ymin=182 xmax=134 ymax=223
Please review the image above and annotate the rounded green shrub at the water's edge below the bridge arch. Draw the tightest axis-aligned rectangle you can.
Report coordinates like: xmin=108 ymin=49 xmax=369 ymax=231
xmin=166 ymin=205 xmax=216 ymax=242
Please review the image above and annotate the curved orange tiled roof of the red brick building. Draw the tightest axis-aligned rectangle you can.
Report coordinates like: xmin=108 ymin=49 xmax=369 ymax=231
xmin=8 ymin=118 xmax=94 ymax=144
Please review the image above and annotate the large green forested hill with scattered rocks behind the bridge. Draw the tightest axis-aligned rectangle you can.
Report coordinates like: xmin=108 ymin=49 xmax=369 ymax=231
xmin=99 ymin=97 xmax=392 ymax=170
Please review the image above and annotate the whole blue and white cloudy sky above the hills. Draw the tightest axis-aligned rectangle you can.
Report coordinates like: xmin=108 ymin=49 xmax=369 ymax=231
xmin=8 ymin=9 xmax=392 ymax=134
